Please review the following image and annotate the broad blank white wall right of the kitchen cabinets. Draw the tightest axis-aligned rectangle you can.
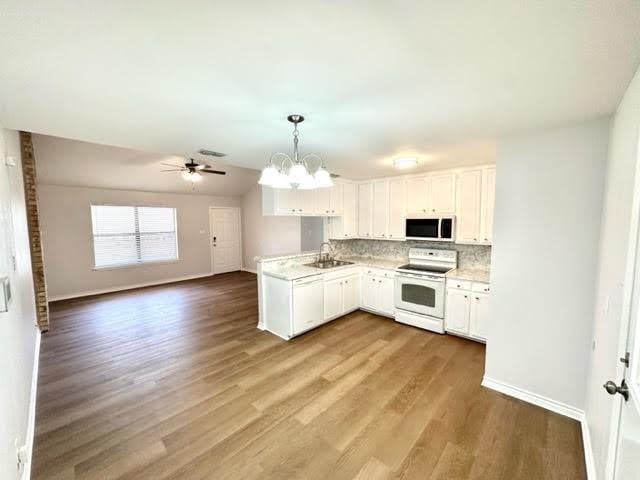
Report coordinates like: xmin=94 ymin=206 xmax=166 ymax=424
xmin=485 ymin=119 xmax=609 ymax=410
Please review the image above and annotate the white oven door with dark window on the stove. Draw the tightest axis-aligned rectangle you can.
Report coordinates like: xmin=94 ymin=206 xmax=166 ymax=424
xmin=395 ymin=273 xmax=444 ymax=318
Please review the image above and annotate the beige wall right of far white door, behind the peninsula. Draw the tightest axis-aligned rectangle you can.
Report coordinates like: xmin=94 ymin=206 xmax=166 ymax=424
xmin=242 ymin=185 xmax=301 ymax=270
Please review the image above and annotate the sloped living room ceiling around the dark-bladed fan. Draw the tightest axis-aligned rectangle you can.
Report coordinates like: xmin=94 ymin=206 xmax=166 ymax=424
xmin=33 ymin=135 xmax=258 ymax=196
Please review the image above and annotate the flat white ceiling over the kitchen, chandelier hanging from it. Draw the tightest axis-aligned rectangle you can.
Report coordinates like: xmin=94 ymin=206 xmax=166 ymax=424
xmin=0 ymin=0 xmax=640 ymax=178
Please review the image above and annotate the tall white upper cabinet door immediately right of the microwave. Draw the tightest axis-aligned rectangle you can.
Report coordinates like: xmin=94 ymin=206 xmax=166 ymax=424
xmin=456 ymin=170 xmax=482 ymax=243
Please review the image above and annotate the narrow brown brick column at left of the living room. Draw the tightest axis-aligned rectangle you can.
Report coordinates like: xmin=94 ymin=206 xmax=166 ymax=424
xmin=20 ymin=132 xmax=49 ymax=332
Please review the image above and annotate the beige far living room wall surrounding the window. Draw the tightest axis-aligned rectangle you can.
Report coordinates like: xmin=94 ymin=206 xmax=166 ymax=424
xmin=36 ymin=185 xmax=241 ymax=299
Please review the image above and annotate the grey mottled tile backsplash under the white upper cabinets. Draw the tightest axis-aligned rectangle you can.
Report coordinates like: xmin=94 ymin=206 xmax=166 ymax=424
xmin=331 ymin=239 xmax=491 ymax=270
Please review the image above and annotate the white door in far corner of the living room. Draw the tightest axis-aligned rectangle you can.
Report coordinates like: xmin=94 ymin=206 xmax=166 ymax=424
xmin=209 ymin=207 xmax=242 ymax=275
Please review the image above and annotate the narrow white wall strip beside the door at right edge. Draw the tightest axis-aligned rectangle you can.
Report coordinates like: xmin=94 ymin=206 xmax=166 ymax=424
xmin=586 ymin=65 xmax=640 ymax=478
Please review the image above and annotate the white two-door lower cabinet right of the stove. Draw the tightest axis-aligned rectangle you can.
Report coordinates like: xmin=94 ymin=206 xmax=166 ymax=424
xmin=444 ymin=280 xmax=489 ymax=342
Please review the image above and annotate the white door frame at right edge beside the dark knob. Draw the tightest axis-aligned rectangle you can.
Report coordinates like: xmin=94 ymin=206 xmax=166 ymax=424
xmin=597 ymin=129 xmax=640 ymax=480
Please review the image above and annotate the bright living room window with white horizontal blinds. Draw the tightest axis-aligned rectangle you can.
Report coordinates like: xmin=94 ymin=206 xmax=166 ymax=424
xmin=91 ymin=205 xmax=178 ymax=268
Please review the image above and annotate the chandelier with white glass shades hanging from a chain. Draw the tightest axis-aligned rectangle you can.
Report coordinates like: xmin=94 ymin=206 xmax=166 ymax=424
xmin=258 ymin=115 xmax=333 ymax=190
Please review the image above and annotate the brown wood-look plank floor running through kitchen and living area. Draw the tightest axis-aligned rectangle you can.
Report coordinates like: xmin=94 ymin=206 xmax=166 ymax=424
xmin=33 ymin=272 xmax=585 ymax=480
